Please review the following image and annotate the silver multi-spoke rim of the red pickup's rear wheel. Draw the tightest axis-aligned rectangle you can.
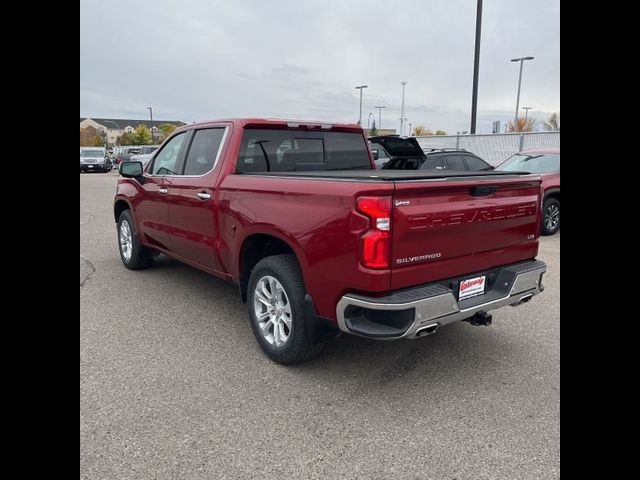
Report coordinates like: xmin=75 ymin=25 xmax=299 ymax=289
xmin=253 ymin=275 xmax=292 ymax=347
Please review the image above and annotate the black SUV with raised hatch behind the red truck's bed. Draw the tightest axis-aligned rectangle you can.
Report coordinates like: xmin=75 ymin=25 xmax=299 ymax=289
xmin=369 ymin=135 xmax=493 ymax=172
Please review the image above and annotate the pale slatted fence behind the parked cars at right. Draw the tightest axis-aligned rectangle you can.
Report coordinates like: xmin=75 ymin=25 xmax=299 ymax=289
xmin=416 ymin=132 xmax=560 ymax=167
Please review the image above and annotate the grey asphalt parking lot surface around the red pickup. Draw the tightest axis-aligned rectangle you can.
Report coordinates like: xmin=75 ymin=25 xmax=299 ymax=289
xmin=80 ymin=172 xmax=560 ymax=480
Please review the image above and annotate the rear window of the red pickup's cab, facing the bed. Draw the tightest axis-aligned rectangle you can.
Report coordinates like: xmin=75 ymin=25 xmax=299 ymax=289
xmin=236 ymin=129 xmax=372 ymax=173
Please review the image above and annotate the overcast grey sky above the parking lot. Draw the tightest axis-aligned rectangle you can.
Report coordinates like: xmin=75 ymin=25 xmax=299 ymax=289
xmin=80 ymin=0 xmax=560 ymax=133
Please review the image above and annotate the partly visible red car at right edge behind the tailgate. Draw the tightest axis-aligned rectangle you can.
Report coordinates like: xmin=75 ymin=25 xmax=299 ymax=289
xmin=496 ymin=148 xmax=560 ymax=235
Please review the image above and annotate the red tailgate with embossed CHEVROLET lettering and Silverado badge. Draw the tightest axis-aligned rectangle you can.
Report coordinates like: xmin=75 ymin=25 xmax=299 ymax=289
xmin=391 ymin=175 xmax=541 ymax=290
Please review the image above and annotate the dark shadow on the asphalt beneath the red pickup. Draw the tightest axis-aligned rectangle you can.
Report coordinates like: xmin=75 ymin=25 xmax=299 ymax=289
xmin=143 ymin=256 xmax=533 ymax=397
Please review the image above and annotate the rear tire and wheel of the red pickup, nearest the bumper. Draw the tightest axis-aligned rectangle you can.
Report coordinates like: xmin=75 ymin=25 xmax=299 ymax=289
xmin=247 ymin=255 xmax=324 ymax=365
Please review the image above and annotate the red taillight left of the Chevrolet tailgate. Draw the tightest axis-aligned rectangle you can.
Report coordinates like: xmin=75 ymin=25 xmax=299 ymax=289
xmin=356 ymin=197 xmax=391 ymax=268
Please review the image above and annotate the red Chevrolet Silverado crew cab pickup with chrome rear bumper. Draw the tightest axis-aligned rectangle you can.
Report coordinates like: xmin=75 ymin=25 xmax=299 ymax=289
xmin=113 ymin=119 xmax=546 ymax=364
